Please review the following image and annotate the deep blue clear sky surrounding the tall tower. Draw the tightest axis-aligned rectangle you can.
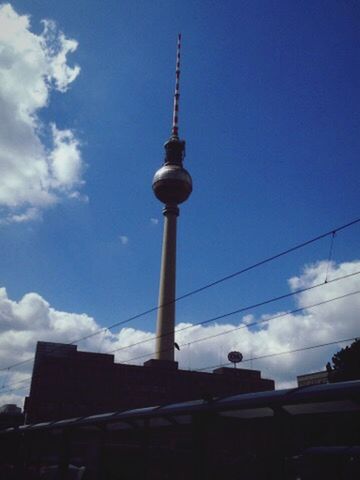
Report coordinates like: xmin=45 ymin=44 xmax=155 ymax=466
xmin=0 ymin=0 xmax=360 ymax=402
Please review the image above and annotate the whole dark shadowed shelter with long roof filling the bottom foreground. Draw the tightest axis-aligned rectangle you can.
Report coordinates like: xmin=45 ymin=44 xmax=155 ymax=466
xmin=0 ymin=381 xmax=360 ymax=480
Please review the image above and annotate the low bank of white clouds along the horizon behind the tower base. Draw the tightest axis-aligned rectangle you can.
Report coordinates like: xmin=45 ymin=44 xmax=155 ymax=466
xmin=0 ymin=260 xmax=360 ymax=405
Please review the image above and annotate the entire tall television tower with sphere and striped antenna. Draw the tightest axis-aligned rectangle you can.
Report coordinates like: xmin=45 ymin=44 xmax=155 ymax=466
xmin=152 ymin=34 xmax=192 ymax=361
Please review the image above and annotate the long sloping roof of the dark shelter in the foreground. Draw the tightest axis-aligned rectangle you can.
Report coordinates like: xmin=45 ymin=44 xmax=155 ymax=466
xmin=0 ymin=380 xmax=360 ymax=434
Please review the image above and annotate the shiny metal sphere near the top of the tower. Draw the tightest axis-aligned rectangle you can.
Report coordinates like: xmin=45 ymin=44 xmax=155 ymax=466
xmin=152 ymin=164 xmax=192 ymax=204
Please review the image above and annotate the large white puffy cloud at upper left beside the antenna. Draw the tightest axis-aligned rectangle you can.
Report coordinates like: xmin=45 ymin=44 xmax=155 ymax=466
xmin=0 ymin=4 xmax=82 ymax=223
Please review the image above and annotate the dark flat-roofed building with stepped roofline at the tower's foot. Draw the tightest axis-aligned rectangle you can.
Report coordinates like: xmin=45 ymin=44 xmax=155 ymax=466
xmin=24 ymin=342 xmax=274 ymax=423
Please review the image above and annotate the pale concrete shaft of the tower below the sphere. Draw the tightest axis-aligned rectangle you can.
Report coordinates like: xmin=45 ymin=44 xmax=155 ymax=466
xmin=156 ymin=205 xmax=179 ymax=361
